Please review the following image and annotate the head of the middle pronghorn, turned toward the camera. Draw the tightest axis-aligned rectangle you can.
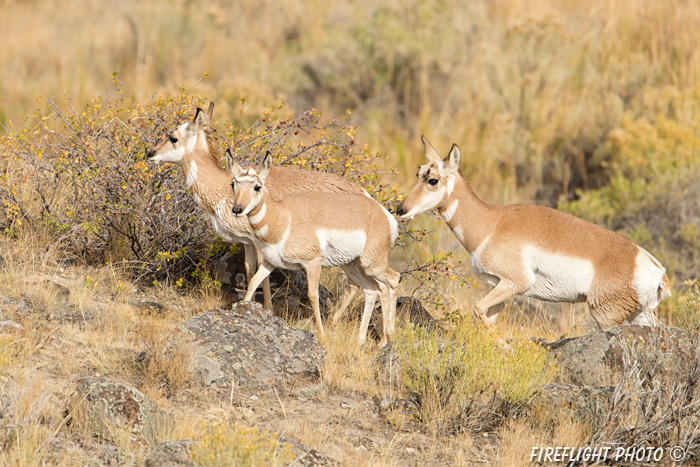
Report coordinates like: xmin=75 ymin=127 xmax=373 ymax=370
xmin=231 ymin=149 xmax=272 ymax=217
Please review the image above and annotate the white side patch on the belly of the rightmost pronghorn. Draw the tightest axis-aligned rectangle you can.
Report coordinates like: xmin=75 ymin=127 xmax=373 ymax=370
xmin=522 ymin=246 xmax=595 ymax=302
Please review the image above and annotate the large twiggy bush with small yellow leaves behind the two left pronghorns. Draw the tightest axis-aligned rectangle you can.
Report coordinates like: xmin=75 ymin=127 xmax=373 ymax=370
xmin=0 ymin=76 xmax=400 ymax=285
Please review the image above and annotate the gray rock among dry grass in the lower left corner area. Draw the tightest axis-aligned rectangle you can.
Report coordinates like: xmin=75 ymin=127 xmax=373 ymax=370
xmin=68 ymin=378 xmax=172 ymax=443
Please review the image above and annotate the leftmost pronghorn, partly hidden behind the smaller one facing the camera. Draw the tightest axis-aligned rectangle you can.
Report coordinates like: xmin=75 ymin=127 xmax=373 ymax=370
xmin=148 ymin=102 xmax=367 ymax=308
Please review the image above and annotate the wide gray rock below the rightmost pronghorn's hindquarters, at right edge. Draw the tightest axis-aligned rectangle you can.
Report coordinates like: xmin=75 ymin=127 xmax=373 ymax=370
xmin=544 ymin=325 xmax=698 ymax=386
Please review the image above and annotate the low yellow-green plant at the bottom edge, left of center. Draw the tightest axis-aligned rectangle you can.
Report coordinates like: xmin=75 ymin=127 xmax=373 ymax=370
xmin=190 ymin=424 xmax=295 ymax=467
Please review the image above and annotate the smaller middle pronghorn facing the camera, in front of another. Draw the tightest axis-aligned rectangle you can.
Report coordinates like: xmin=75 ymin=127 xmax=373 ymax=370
xmin=231 ymin=153 xmax=400 ymax=345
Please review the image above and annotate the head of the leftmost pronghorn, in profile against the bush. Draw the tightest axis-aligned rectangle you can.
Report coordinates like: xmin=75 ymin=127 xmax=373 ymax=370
xmin=148 ymin=102 xmax=214 ymax=162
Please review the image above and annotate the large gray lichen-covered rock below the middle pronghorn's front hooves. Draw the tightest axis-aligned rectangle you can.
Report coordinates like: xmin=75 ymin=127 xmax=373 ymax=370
xmin=170 ymin=302 xmax=326 ymax=388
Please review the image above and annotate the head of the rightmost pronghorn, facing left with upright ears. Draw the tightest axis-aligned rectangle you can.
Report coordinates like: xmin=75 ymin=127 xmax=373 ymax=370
xmin=396 ymin=136 xmax=462 ymax=219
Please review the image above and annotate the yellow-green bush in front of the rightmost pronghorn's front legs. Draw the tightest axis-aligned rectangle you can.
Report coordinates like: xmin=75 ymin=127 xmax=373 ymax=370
xmin=395 ymin=320 xmax=555 ymax=432
